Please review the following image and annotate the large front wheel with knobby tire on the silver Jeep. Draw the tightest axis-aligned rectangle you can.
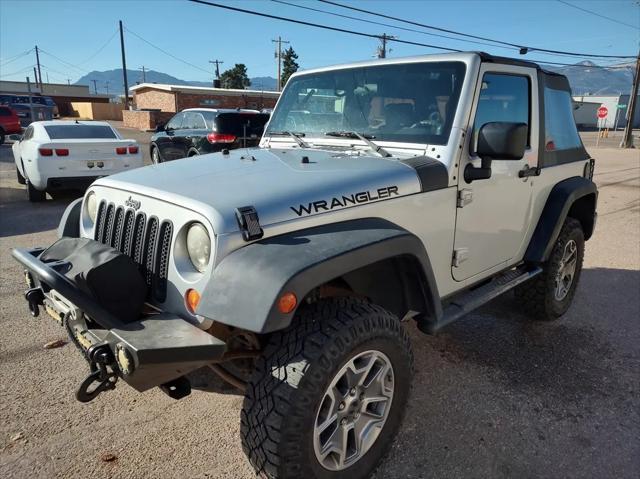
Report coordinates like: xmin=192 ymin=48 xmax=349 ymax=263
xmin=240 ymin=298 xmax=413 ymax=479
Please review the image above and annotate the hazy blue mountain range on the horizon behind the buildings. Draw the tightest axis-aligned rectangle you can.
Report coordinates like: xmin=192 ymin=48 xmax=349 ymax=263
xmin=75 ymin=61 xmax=635 ymax=95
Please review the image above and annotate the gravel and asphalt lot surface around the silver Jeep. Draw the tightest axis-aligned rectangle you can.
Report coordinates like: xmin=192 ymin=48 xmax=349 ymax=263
xmin=0 ymin=130 xmax=640 ymax=478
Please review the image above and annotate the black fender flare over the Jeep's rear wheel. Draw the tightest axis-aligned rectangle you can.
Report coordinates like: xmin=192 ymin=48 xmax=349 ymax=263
xmin=524 ymin=176 xmax=598 ymax=263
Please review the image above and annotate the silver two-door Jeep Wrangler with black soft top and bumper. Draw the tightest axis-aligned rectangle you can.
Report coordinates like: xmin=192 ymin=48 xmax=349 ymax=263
xmin=13 ymin=53 xmax=597 ymax=478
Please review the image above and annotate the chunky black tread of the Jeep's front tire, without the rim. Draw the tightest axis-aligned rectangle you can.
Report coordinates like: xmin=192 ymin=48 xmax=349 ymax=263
xmin=240 ymin=297 xmax=413 ymax=478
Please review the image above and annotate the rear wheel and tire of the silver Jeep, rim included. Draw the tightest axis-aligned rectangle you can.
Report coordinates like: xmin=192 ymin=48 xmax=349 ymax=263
xmin=514 ymin=218 xmax=584 ymax=321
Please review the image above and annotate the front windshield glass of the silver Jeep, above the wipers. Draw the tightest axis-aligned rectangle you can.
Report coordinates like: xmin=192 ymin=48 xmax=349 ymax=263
xmin=267 ymin=62 xmax=465 ymax=145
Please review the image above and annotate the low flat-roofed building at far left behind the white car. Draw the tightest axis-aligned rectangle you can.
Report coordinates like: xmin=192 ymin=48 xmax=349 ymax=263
xmin=0 ymin=81 xmax=110 ymax=116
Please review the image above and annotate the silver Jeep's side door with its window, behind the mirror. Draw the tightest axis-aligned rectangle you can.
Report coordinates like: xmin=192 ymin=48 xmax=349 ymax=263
xmin=452 ymin=64 xmax=539 ymax=281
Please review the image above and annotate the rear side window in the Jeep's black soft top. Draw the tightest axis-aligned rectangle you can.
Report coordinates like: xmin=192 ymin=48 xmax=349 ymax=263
xmin=544 ymin=86 xmax=582 ymax=151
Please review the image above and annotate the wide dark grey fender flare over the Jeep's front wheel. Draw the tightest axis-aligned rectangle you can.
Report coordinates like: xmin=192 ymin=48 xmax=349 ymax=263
xmin=196 ymin=218 xmax=442 ymax=333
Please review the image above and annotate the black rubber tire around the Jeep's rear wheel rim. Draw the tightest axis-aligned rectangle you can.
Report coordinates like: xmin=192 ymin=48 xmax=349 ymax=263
xmin=514 ymin=217 xmax=584 ymax=321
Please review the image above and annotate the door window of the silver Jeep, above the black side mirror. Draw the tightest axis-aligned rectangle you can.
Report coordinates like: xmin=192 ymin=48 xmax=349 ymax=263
xmin=473 ymin=73 xmax=531 ymax=150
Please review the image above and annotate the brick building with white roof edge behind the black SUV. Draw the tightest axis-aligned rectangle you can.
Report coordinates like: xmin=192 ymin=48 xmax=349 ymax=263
xmin=123 ymin=83 xmax=280 ymax=130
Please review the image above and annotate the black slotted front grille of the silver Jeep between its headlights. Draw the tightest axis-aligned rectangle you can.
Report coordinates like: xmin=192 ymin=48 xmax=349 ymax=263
xmin=95 ymin=201 xmax=173 ymax=302
